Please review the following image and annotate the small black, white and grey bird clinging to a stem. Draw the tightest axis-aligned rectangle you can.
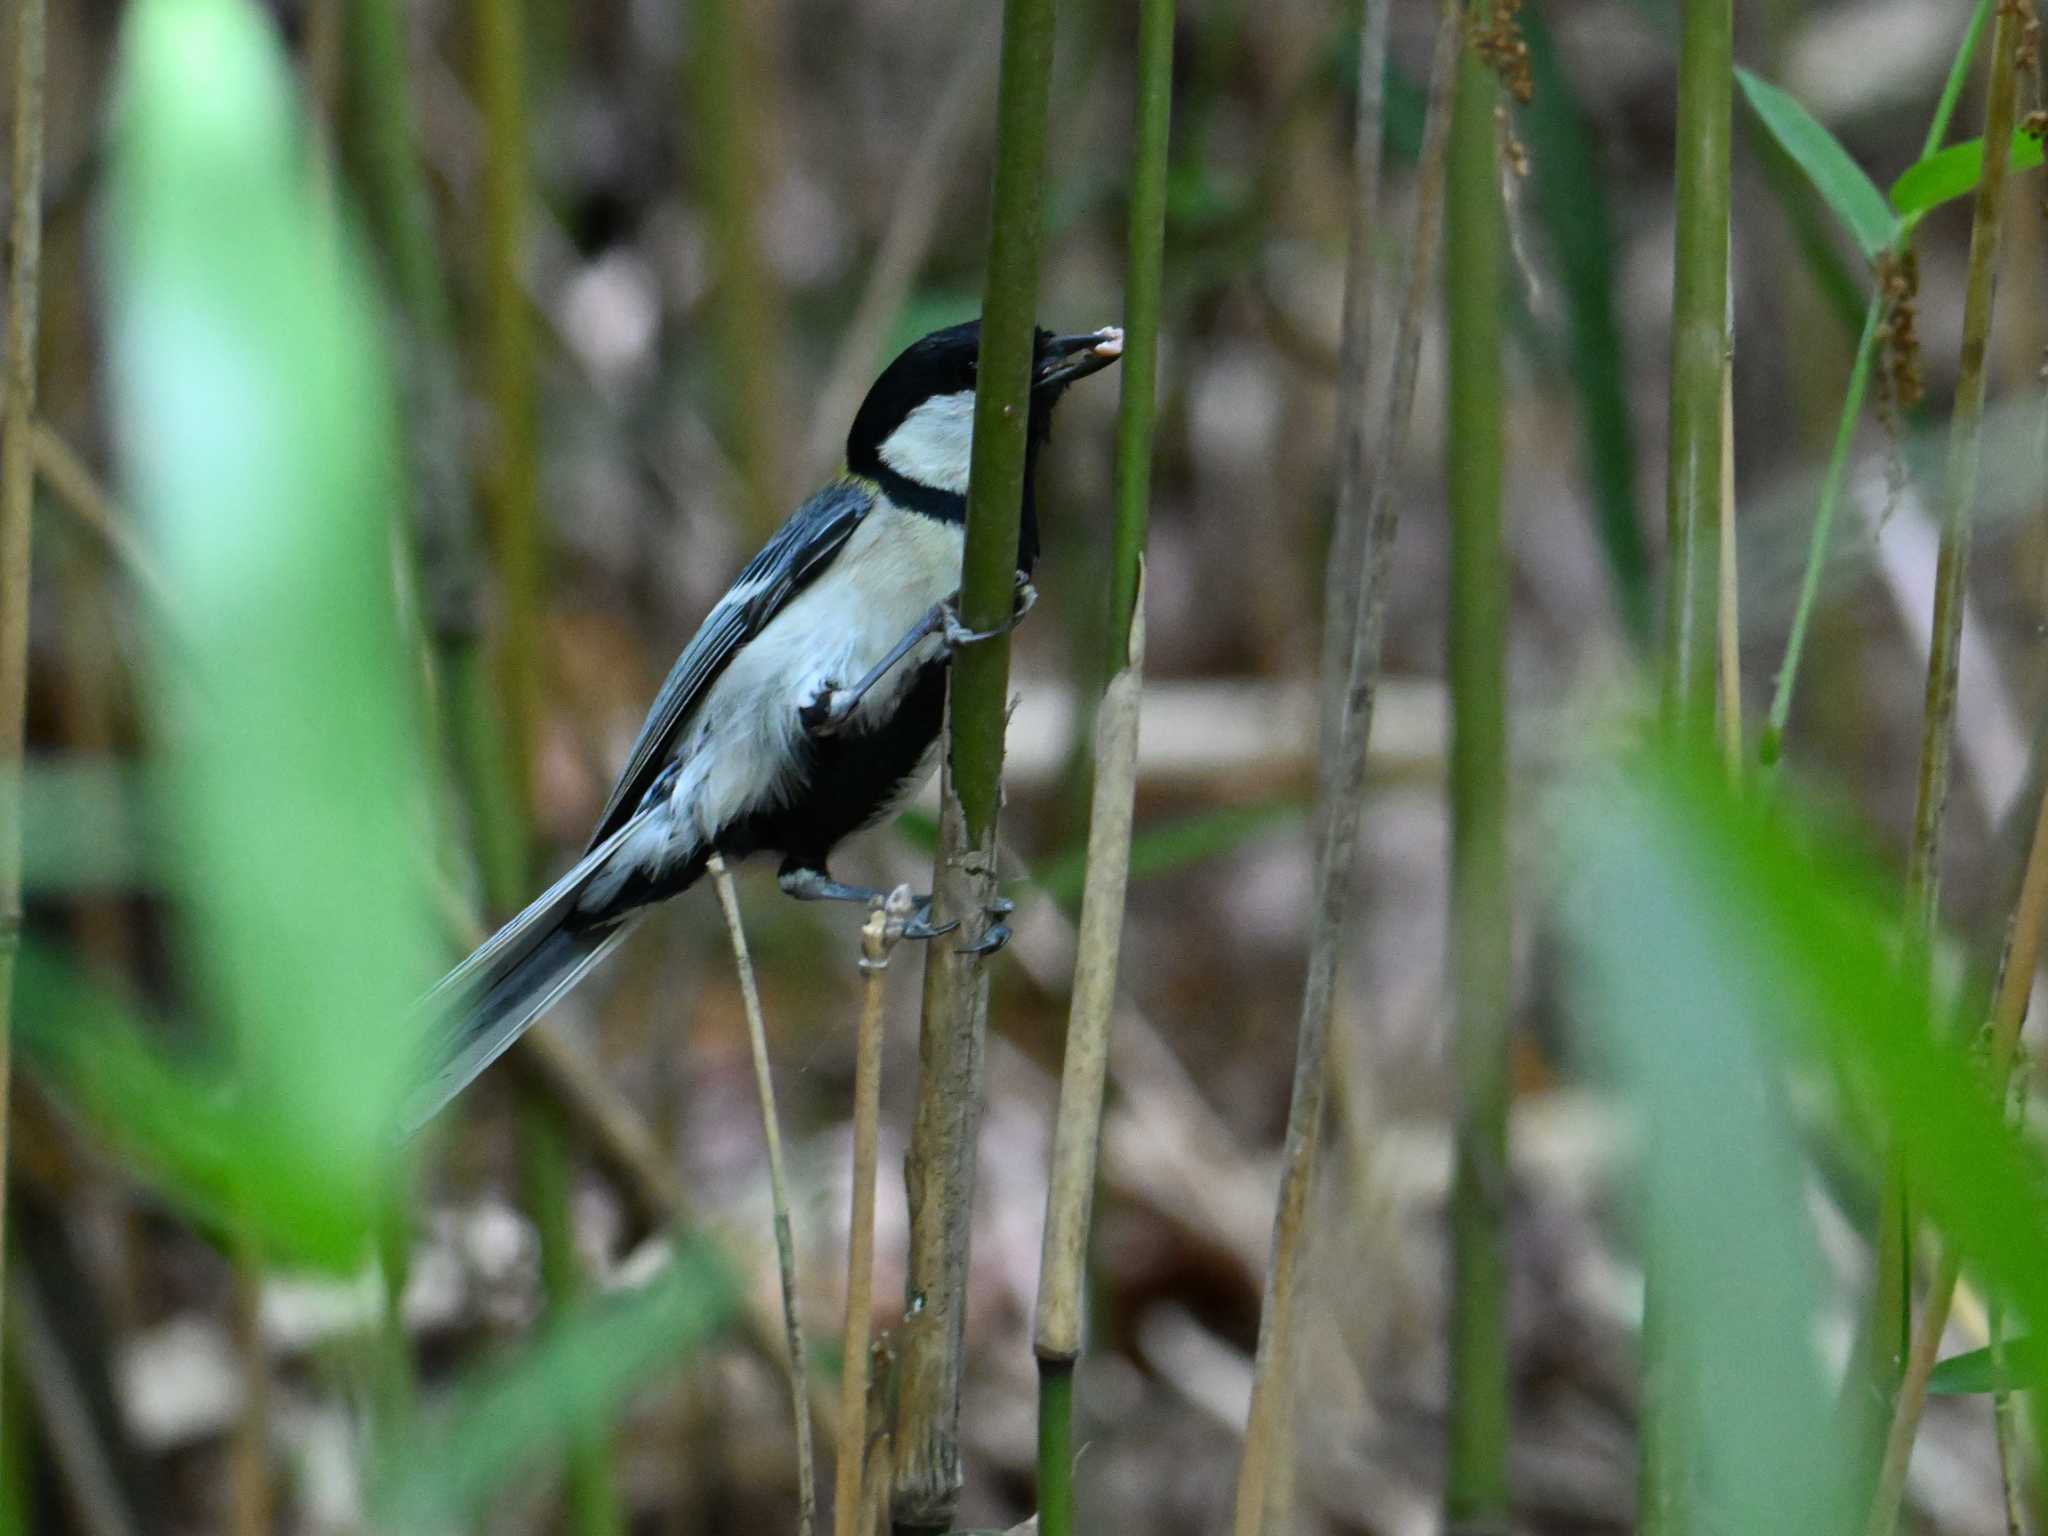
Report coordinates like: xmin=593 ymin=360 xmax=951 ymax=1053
xmin=410 ymin=322 xmax=1124 ymax=1126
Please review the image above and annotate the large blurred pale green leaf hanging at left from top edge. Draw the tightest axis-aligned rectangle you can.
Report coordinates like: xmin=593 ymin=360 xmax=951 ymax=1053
xmin=109 ymin=0 xmax=436 ymax=1266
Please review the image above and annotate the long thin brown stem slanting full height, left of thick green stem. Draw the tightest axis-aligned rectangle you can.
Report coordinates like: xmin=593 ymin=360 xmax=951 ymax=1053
xmin=1235 ymin=4 xmax=1460 ymax=1536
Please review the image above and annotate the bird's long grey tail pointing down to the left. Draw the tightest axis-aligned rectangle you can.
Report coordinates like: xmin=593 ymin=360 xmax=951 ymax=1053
xmin=406 ymin=821 xmax=641 ymax=1135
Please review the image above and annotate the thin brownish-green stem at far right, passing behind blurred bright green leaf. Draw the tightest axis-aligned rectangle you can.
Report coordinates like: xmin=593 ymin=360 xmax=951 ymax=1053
xmin=1870 ymin=6 xmax=2032 ymax=1393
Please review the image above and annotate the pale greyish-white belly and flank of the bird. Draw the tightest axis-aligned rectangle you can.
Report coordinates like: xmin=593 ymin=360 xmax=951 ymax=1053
xmin=670 ymin=502 xmax=965 ymax=842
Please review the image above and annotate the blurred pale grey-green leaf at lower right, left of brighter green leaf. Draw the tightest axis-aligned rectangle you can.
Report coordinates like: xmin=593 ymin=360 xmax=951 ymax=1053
xmin=1559 ymin=741 xmax=1847 ymax=1536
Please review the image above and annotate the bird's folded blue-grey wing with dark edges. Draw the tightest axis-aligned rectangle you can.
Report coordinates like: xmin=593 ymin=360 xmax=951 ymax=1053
xmin=590 ymin=479 xmax=874 ymax=848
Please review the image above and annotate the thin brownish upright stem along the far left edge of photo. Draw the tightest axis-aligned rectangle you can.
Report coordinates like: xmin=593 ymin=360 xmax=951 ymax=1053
xmin=0 ymin=0 xmax=47 ymax=1425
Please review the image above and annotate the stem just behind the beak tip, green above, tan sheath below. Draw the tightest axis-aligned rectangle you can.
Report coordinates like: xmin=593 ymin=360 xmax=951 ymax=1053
xmin=1032 ymin=0 xmax=1174 ymax=1536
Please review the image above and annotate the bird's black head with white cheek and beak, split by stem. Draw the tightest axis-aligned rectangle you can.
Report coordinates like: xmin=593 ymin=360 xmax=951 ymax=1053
xmin=846 ymin=319 xmax=1124 ymax=516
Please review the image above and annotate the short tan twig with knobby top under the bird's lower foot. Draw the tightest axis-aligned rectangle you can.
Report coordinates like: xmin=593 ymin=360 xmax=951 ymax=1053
xmin=831 ymin=885 xmax=911 ymax=1536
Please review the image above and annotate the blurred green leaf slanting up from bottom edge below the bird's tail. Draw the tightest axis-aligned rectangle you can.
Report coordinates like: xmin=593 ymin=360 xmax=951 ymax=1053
xmin=375 ymin=1239 xmax=741 ymax=1532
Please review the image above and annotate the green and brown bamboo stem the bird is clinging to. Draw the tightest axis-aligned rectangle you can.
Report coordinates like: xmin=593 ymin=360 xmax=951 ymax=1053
xmin=889 ymin=0 xmax=1053 ymax=1530
